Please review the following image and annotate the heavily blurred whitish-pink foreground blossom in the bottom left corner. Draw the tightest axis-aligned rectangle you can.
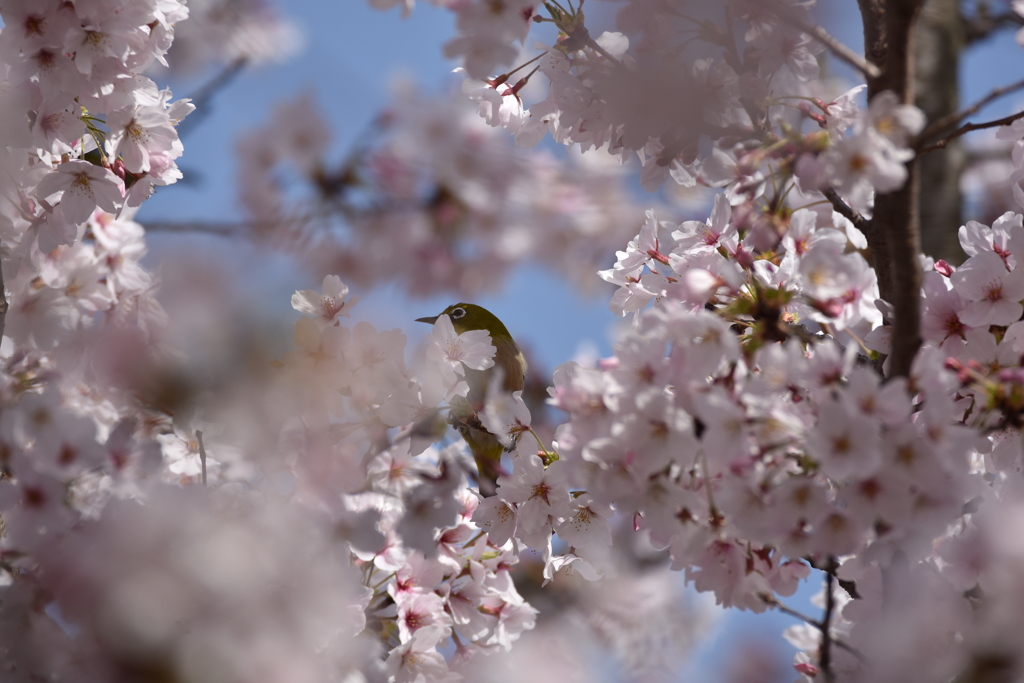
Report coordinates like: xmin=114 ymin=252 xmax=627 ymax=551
xmin=12 ymin=487 xmax=374 ymax=683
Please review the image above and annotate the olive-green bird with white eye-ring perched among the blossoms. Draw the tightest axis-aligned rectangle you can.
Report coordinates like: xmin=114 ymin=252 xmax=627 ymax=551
xmin=416 ymin=303 xmax=526 ymax=498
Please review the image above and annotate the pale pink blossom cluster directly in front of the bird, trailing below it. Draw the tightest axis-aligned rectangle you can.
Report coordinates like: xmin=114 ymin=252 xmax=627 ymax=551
xmin=253 ymin=275 xmax=536 ymax=681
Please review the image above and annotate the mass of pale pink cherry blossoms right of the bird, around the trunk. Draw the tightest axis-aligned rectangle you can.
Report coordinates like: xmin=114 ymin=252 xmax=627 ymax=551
xmin=364 ymin=3 xmax=1024 ymax=680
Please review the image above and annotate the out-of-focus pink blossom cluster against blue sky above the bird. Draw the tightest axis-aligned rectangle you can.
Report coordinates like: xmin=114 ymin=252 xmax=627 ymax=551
xmin=238 ymin=87 xmax=643 ymax=296
